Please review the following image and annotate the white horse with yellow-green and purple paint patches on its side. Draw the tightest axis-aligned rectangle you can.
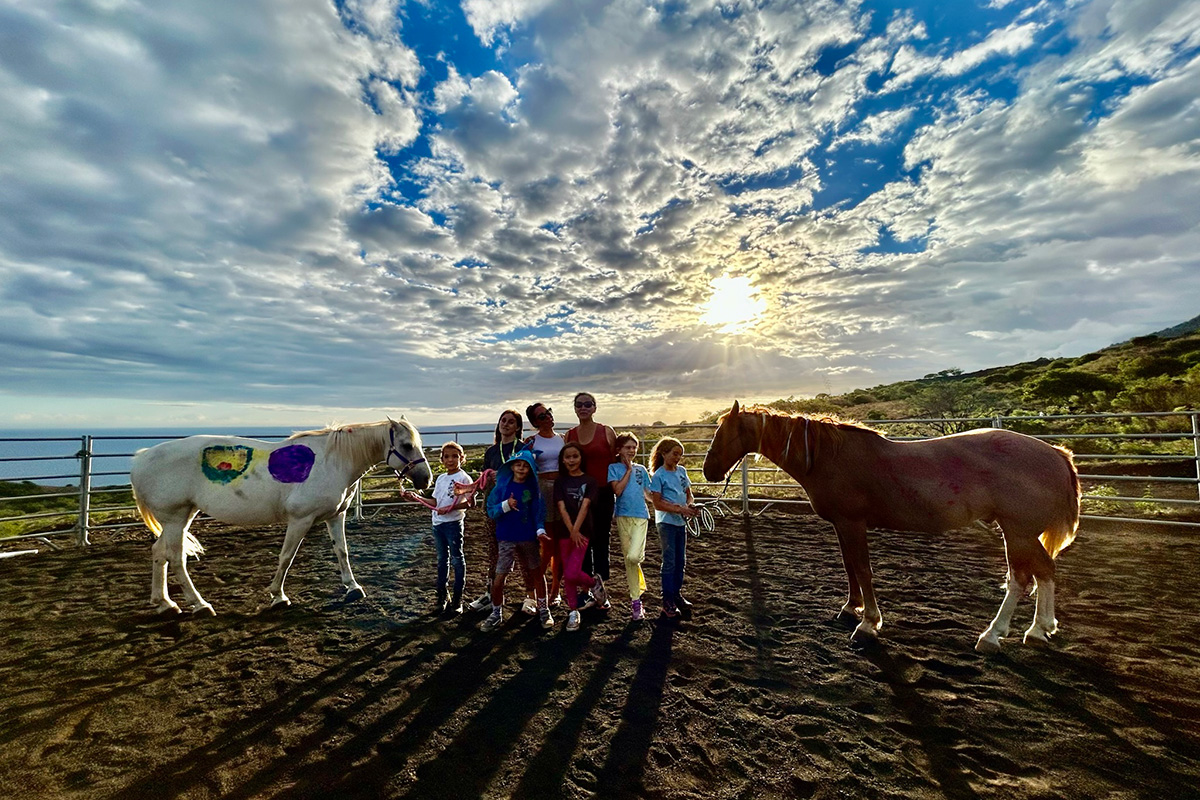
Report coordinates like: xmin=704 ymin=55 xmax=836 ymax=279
xmin=130 ymin=417 xmax=432 ymax=615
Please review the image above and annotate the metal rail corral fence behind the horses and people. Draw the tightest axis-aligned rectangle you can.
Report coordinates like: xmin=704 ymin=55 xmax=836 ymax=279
xmin=0 ymin=411 xmax=1200 ymax=547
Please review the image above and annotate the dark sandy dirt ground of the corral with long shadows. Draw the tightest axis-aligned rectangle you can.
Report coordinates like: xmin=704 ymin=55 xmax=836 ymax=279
xmin=0 ymin=511 xmax=1200 ymax=800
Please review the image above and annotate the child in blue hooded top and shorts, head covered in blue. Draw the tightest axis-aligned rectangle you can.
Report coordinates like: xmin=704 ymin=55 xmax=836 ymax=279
xmin=479 ymin=451 xmax=554 ymax=631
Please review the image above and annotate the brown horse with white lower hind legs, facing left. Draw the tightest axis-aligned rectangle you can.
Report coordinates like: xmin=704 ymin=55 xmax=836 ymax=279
xmin=704 ymin=402 xmax=1079 ymax=652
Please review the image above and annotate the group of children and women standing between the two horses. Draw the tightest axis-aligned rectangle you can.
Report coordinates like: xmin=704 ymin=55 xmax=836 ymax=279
xmin=404 ymin=396 xmax=698 ymax=631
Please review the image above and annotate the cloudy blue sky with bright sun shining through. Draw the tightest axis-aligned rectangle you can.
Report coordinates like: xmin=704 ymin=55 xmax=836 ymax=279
xmin=0 ymin=0 xmax=1200 ymax=427
